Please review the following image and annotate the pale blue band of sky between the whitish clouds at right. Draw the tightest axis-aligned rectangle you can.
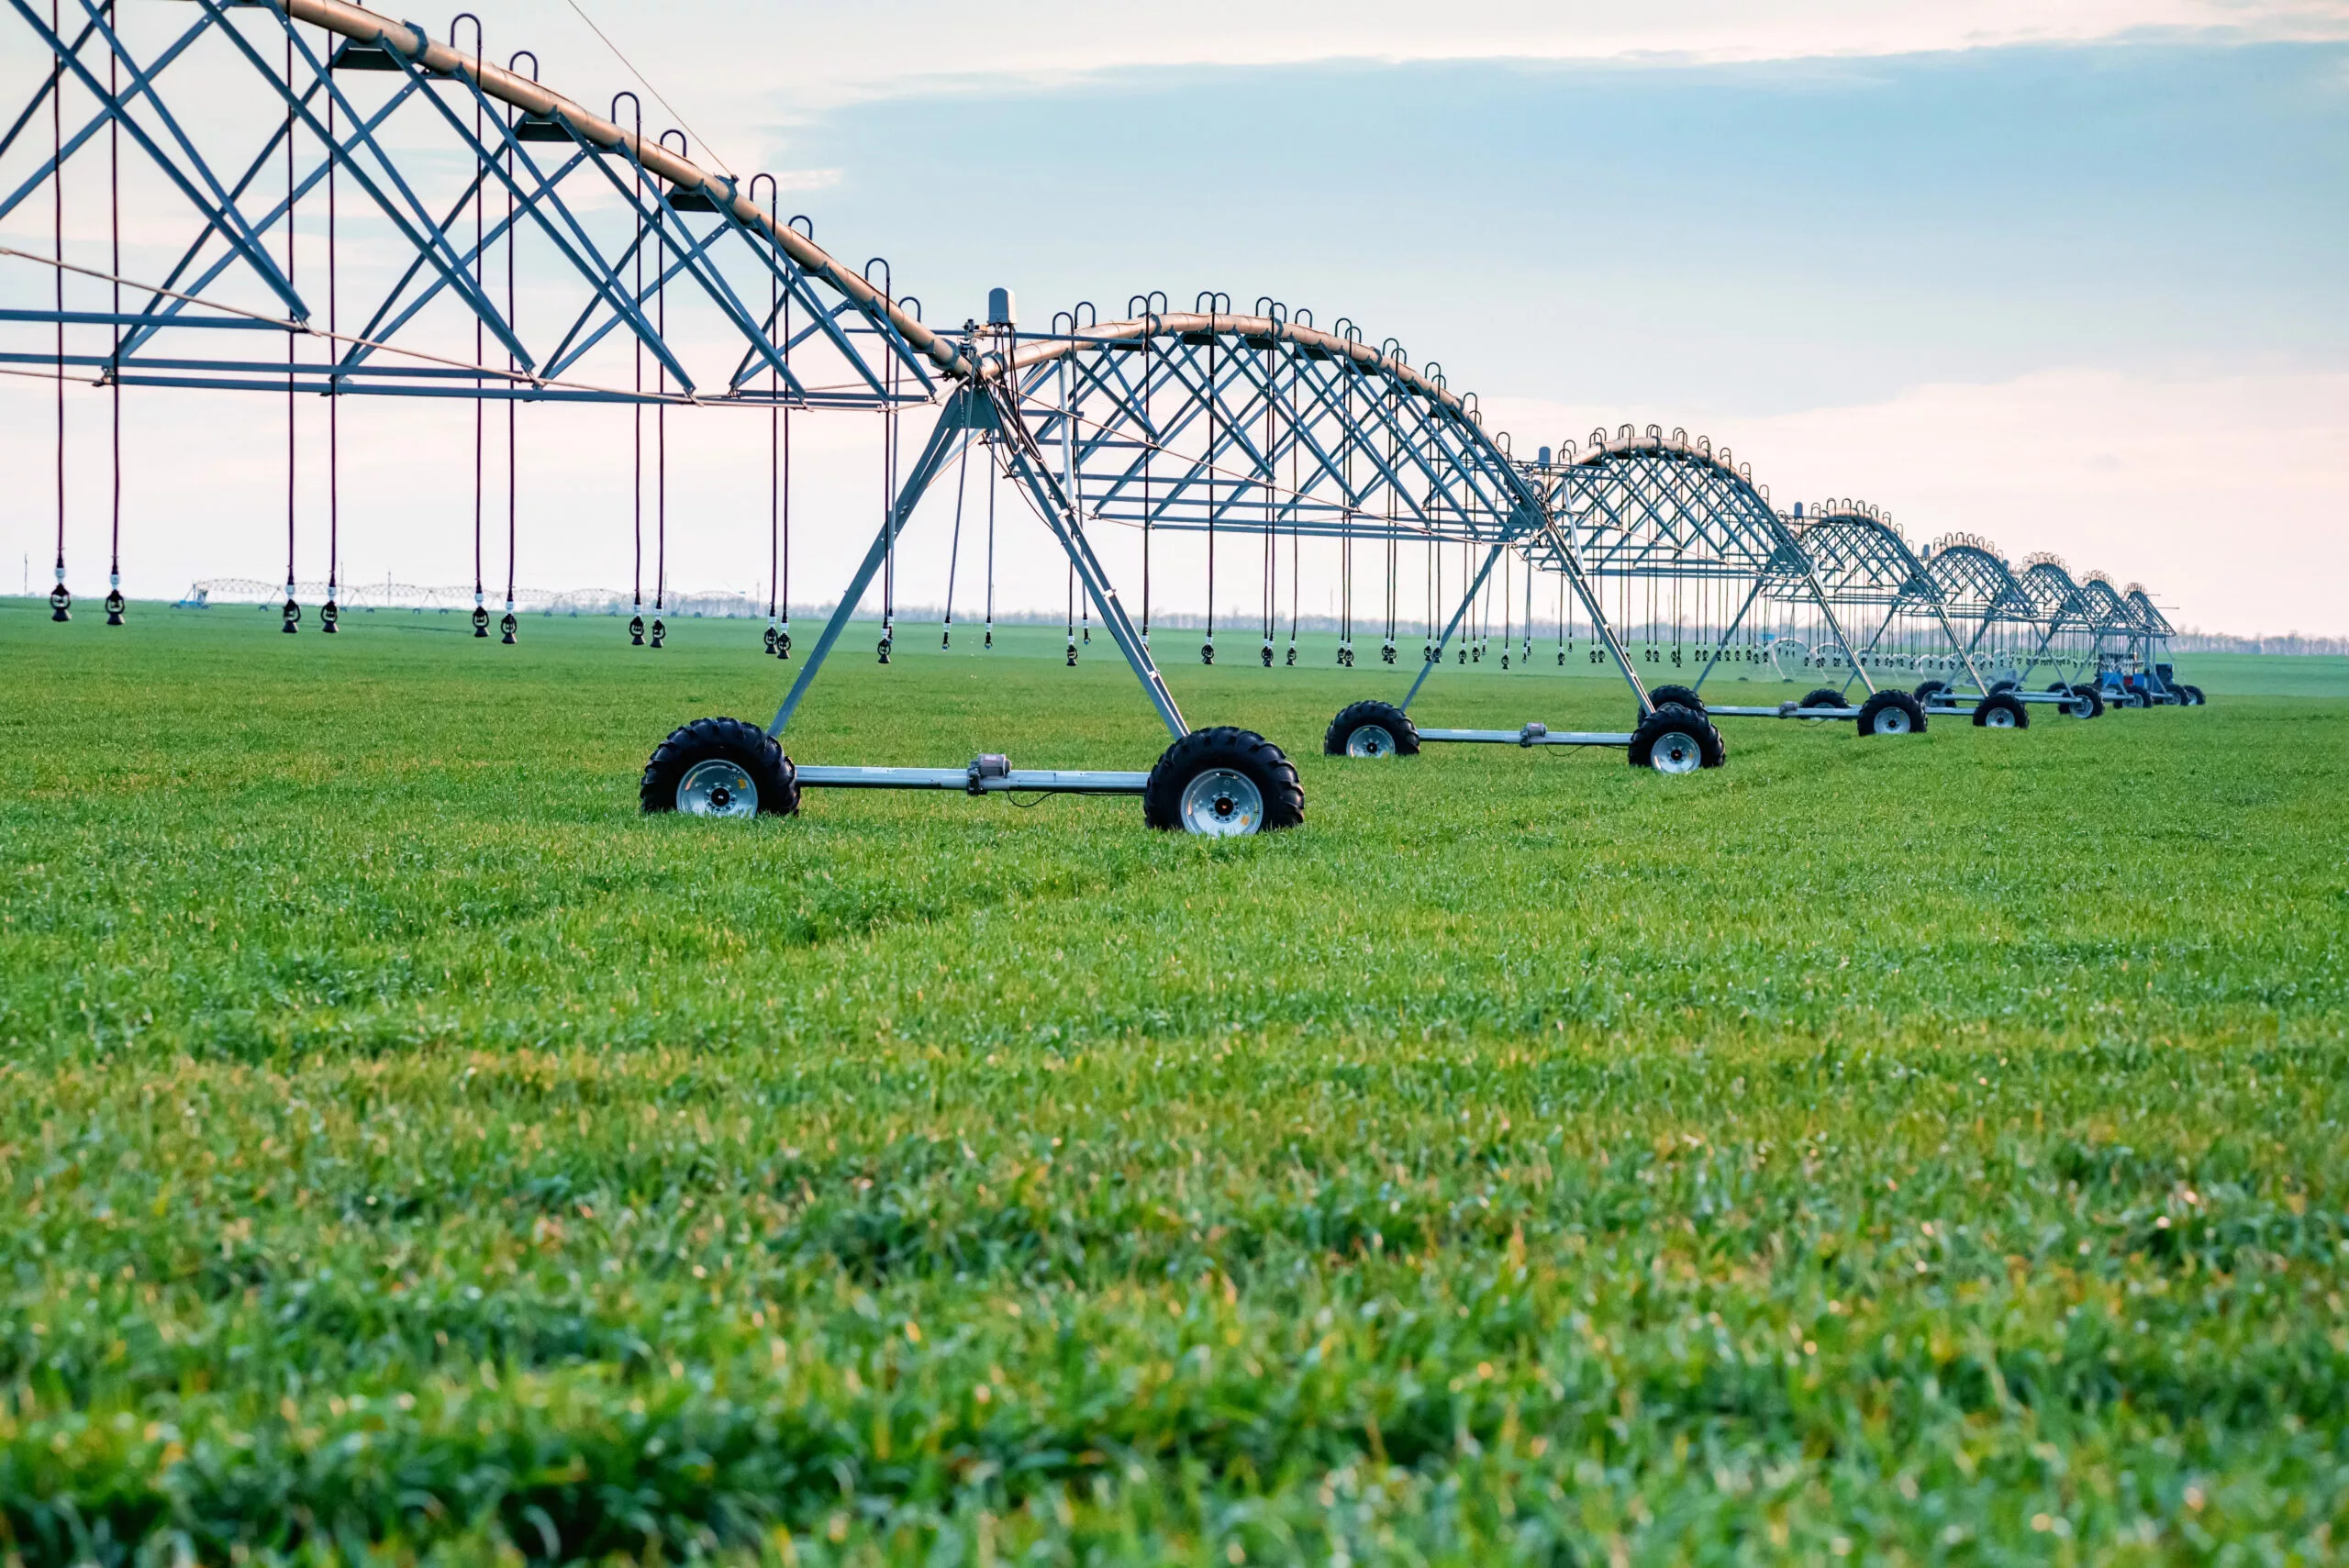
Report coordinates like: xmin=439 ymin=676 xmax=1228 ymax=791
xmin=785 ymin=42 xmax=2349 ymax=413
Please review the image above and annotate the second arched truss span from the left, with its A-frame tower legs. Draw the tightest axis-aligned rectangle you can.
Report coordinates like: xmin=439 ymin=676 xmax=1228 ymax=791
xmin=771 ymin=298 xmax=1647 ymax=737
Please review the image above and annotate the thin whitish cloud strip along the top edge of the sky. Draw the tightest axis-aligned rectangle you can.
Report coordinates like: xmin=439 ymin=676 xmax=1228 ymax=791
xmin=485 ymin=0 xmax=2349 ymax=131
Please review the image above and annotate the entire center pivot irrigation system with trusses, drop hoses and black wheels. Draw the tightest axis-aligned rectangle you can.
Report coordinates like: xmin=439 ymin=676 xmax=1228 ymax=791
xmin=0 ymin=0 xmax=2201 ymax=836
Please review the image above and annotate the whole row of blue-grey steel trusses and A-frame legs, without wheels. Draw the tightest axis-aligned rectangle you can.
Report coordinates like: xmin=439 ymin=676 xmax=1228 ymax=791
xmin=0 ymin=0 xmax=2168 ymax=817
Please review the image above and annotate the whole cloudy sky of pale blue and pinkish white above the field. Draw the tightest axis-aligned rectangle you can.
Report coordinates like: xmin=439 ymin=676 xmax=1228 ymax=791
xmin=0 ymin=0 xmax=2349 ymax=636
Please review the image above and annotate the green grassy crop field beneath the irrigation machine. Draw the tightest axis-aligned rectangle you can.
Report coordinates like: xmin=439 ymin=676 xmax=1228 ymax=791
xmin=0 ymin=601 xmax=2349 ymax=1565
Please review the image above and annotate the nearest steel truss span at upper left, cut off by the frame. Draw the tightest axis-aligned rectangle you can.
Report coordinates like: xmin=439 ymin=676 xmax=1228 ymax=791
xmin=0 ymin=0 xmax=968 ymax=408
